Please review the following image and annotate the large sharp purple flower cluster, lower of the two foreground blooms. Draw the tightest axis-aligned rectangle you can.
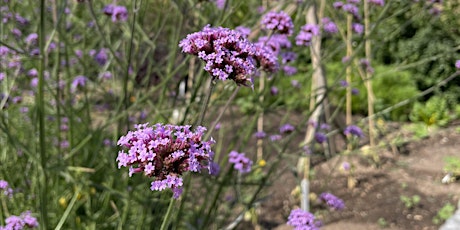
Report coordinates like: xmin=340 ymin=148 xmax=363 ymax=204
xmin=117 ymin=123 xmax=214 ymax=198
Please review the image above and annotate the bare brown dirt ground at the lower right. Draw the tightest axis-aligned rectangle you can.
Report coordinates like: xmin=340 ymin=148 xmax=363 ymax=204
xmin=255 ymin=122 xmax=460 ymax=230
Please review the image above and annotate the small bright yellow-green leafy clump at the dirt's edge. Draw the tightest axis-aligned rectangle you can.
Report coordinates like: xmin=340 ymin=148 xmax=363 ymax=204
xmin=409 ymin=96 xmax=451 ymax=126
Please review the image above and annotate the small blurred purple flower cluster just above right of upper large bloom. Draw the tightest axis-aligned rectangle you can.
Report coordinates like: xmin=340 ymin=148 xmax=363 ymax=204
xmin=261 ymin=11 xmax=294 ymax=36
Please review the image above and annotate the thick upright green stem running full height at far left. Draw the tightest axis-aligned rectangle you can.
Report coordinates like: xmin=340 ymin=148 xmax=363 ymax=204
xmin=36 ymin=0 xmax=48 ymax=229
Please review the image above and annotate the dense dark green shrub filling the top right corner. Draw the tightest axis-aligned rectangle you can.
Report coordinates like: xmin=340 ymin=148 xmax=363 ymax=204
xmin=374 ymin=1 xmax=460 ymax=101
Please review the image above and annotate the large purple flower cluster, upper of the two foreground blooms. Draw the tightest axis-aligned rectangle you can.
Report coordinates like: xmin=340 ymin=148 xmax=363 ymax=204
xmin=179 ymin=25 xmax=278 ymax=86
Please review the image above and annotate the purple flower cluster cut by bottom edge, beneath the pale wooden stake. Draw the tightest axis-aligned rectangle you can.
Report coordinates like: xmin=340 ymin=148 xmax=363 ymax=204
xmin=287 ymin=208 xmax=322 ymax=230
